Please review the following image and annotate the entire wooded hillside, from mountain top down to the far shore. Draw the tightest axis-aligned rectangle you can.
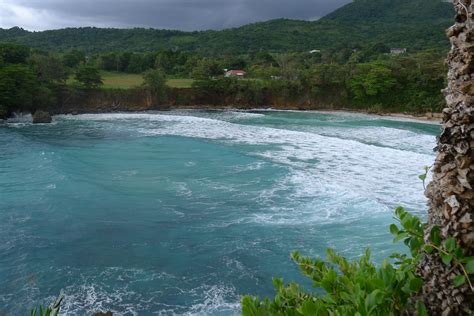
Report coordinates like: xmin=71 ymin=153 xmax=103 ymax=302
xmin=0 ymin=0 xmax=453 ymax=117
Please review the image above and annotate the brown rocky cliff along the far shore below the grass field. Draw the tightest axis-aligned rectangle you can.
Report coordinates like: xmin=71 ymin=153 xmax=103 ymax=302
xmin=39 ymin=88 xmax=345 ymax=114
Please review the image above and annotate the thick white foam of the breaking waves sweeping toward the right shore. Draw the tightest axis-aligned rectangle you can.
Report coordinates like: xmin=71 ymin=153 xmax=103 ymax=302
xmin=62 ymin=113 xmax=434 ymax=217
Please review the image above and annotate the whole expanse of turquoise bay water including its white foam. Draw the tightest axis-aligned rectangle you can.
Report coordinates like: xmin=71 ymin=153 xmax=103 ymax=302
xmin=0 ymin=111 xmax=439 ymax=315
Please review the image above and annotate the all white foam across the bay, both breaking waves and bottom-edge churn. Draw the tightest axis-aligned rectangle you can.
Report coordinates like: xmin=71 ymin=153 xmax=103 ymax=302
xmin=0 ymin=111 xmax=434 ymax=315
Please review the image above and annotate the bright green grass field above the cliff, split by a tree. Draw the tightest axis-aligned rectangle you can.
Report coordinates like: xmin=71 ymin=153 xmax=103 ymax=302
xmin=68 ymin=71 xmax=194 ymax=89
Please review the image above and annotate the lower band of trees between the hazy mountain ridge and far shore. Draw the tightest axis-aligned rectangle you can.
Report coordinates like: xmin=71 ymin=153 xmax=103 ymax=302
xmin=0 ymin=40 xmax=446 ymax=117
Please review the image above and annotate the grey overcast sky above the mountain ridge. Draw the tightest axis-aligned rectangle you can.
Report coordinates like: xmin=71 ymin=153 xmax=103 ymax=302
xmin=0 ymin=0 xmax=350 ymax=31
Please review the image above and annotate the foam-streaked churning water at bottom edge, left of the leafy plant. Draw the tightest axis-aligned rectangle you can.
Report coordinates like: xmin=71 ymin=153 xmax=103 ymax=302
xmin=55 ymin=267 xmax=240 ymax=315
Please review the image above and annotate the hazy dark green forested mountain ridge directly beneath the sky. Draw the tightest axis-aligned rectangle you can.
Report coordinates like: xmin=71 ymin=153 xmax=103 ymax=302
xmin=0 ymin=0 xmax=453 ymax=53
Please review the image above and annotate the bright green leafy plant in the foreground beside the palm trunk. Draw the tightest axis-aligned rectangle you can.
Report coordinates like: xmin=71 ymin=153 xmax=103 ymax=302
xmin=242 ymin=207 xmax=474 ymax=316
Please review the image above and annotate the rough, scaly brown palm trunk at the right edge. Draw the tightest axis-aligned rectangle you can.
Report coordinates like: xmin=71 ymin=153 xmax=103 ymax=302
xmin=418 ymin=0 xmax=474 ymax=315
